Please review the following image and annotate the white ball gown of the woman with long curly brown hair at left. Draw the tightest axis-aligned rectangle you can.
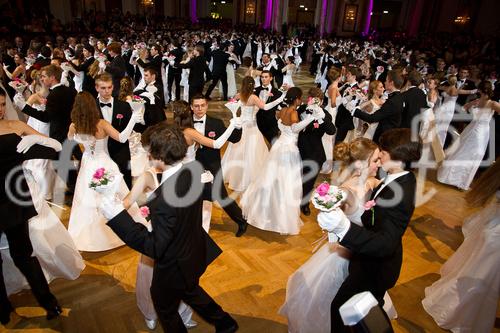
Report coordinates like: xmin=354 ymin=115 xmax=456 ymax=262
xmin=68 ymin=134 xmax=141 ymax=252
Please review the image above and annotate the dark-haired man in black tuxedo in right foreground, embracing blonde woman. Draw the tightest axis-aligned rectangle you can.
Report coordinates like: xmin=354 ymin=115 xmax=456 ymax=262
xmin=324 ymin=127 xmax=420 ymax=333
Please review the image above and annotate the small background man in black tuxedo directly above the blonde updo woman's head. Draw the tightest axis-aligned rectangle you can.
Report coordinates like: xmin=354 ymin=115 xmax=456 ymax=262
xmin=335 ymin=67 xmax=361 ymax=142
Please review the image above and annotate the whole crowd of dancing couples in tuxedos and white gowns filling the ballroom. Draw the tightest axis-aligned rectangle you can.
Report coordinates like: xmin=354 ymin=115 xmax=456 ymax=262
xmin=0 ymin=18 xmax=500 ymax=332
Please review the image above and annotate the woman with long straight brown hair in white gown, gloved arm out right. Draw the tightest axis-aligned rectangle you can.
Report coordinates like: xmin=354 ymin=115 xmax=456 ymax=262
xmin=221 ymin=76 xmax=284 ymax=192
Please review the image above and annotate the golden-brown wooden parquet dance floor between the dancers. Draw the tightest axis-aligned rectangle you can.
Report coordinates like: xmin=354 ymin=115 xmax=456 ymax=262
xmin=0 ymin=71 xmax=500 ymax=333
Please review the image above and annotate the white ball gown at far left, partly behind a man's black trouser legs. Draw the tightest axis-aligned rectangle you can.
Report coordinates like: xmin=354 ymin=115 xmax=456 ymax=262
xmin=0 ymin=162 xmax=85 ymax=295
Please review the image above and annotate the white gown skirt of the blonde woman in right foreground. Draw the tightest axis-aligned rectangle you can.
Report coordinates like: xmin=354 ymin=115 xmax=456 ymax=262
xmin=279 ymin=189 xmax=397 ymax=333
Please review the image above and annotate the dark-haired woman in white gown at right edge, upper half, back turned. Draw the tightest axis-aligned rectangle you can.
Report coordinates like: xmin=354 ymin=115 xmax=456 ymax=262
xmin=437 ymin=81 xmax=500 ymax=190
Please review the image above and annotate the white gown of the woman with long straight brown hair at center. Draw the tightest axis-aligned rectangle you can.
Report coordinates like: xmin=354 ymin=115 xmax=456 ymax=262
xmin=221 ymin=105 xmax=269 ymax=192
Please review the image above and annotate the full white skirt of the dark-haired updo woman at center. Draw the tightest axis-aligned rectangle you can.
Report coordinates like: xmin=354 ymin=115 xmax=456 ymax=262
xmin=241 ymin=134 xmax=303 ymax=235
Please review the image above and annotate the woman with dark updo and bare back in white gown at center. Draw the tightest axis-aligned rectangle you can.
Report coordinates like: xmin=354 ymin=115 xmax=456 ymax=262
xmin=240 ymin=87 xmax=315 ymax=235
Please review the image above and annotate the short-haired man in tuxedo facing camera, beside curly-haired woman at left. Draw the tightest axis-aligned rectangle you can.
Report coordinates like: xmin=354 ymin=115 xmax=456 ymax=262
xmin=95 ymin=73 xmax=144 ymax=188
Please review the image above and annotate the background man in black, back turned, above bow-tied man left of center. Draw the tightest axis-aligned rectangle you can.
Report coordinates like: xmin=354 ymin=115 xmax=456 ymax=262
xmin=179 ymin=45 xmax=212 ymax=100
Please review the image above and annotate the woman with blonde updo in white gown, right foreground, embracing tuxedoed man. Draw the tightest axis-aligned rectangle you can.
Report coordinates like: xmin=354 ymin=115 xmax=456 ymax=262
xmin=279 ymin=138 xmax=396 ymax=333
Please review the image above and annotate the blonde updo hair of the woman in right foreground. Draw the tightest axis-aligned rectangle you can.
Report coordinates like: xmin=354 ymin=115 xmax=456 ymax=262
xmin=333 ymin=138 xmax=378 ymax=169
